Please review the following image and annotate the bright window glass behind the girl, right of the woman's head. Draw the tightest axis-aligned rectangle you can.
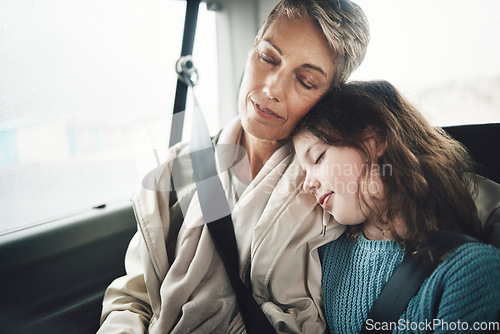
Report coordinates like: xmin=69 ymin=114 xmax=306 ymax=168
xmin=351 ymin=0 xmax=500 ymax=126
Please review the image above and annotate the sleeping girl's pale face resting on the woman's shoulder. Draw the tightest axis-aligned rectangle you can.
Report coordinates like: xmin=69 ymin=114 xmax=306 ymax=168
xmin=294 ymin=132 xmax=381 ymax=225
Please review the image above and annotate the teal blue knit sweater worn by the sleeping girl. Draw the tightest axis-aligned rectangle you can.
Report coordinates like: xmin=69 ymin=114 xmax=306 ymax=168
xmin=319 ymin=234 xmax=500 ymax=333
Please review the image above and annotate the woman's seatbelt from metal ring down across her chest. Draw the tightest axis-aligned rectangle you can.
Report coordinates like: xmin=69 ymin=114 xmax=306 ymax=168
xmin=171 ymin=27 xmax=276 ymax=334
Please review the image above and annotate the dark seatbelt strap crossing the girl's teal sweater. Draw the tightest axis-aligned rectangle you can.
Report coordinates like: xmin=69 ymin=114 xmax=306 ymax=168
xmin=361 ymin=231 xmax=478 ymax=334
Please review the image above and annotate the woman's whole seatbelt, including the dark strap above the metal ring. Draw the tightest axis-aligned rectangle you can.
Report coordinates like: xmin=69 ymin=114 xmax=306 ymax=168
xmin=169 ymin=4 xmax=275 ymax=326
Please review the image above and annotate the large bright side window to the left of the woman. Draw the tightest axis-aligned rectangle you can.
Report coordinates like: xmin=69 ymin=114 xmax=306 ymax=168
xmin=0 ymin=0 xmax=217 ymax=233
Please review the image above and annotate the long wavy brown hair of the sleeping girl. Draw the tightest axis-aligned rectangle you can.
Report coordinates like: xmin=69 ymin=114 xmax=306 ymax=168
xmin=295 ymin=81 xmax=482 ymax=251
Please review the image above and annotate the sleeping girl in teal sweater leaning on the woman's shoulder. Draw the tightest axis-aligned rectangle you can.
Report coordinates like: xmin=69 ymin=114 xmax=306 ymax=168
xmin=294 ymin=81 xmax=500 ymax=333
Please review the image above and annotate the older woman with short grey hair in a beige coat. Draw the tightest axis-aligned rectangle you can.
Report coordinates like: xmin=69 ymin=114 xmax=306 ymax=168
xmin=99 ymin=0 xmax=369 ymax=333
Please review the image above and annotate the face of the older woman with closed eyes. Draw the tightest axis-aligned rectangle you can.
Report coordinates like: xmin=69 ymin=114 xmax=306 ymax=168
xmin=238 ymin=18 xmax=335 ymax=141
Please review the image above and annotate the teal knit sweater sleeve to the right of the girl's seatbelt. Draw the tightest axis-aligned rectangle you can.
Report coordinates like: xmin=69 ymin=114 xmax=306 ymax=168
xmin=426 ymin=243 xmax=500 ymax=333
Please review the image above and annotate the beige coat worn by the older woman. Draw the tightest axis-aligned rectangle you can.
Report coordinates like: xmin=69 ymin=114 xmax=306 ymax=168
xmin=98 ymin=118 xmax=344 ymax=334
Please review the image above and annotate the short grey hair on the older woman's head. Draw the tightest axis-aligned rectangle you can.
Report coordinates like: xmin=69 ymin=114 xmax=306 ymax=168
xmin=257 ymin=0 xmax=370 ymax=87
